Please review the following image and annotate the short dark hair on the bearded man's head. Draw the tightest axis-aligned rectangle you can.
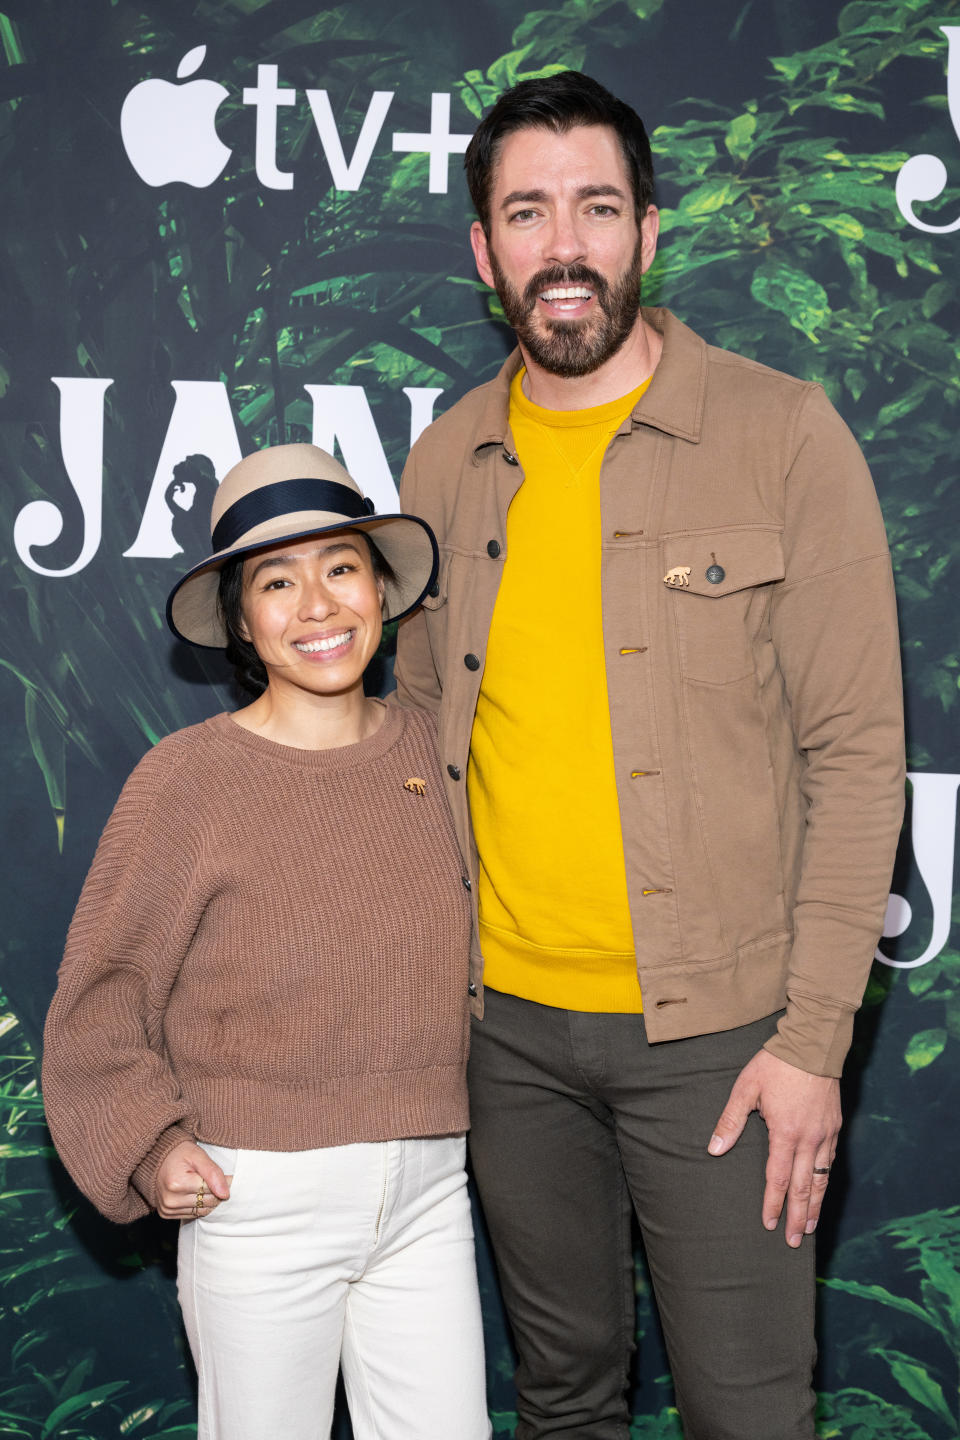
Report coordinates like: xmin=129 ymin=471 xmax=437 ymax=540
xmin=463 ymin=71 xmax=653 ymax=235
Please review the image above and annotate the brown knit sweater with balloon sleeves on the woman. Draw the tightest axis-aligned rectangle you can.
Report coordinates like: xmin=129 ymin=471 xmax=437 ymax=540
xmin=43 ymin=706 xmax=469 ymax=1221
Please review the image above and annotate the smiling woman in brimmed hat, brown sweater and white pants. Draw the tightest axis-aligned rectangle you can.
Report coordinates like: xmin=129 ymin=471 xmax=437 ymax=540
xmin=43 ymin=445 xmax=489 ymax=1440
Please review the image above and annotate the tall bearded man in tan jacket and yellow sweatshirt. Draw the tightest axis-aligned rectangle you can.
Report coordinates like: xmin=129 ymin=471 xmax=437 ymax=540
xmin=397 ymin=72 xmax=904 ymax=1440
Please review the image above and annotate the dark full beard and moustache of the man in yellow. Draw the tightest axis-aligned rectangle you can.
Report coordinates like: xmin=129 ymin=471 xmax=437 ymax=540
xmin=488 ymin=240 xmax=643 ymax=379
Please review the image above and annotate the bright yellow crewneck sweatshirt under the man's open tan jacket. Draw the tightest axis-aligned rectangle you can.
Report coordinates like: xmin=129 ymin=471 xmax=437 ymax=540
xmin=468 ymin=370 xmax=649 ymax=1012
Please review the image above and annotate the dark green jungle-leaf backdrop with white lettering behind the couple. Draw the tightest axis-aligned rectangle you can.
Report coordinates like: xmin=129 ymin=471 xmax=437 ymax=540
xmin=0 ymin=0 xmax=960 ymax=1440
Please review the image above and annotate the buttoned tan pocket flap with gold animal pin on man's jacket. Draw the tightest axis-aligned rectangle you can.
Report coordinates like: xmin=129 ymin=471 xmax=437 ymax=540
xmin=662 ymin=526 xmax=784 ymax=598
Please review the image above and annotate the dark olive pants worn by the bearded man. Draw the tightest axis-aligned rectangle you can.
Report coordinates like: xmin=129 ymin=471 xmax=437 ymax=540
xmin=469 ymin=991 xmax=816 ymax=1440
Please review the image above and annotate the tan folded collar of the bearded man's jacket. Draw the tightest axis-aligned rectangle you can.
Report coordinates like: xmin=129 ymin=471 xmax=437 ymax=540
xmin=474 ymin=307 xmax=707 ymax=451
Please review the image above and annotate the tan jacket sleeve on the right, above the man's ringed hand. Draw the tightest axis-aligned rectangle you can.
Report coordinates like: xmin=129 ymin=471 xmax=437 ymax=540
xmin=767 ymin=386 xmax=905 ymax=1076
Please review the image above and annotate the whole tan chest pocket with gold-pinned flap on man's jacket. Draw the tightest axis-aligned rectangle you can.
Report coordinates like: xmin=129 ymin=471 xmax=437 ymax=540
xmin=662 ymin=526 xmax=784 ymax=685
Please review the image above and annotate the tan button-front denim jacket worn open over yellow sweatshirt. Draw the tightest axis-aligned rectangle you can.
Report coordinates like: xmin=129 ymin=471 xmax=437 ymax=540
xmin=396 ymin=310 xmax=904 ymax=1076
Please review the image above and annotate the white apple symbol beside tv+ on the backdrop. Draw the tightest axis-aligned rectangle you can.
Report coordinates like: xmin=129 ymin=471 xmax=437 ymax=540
xmin=119 ymin=45 xmax=230 ymax=190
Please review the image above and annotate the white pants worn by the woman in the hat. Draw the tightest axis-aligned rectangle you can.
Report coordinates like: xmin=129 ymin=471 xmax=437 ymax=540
xmin=178 ymin=1136 xmax=491 ymax=1440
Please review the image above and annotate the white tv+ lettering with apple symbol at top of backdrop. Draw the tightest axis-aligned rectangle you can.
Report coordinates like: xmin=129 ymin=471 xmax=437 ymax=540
xmin=119 ymin=45 xmax=471 ymax=194
